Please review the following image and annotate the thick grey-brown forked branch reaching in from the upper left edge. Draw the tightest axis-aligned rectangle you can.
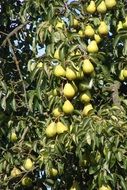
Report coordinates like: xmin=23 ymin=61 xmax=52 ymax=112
xmin=0 ymin=21 xmax=29 ymax=47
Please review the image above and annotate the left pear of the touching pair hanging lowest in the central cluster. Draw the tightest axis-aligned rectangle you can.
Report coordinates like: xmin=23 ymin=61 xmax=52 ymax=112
xmin=45 ymin=122 xmax=56 ymax=137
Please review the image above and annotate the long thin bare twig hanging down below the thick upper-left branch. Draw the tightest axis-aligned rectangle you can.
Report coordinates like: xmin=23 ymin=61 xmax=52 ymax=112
xmin=7 ymin=38 xmax=28 ymax=106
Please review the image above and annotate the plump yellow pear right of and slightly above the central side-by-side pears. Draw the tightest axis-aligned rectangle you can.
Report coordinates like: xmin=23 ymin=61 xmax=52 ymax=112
xmin=82 ymin=59 xmax=94 ymax=74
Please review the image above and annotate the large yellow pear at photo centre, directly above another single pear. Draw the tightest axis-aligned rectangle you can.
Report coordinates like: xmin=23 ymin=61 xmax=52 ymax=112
xmin=63 ymin=83 xmax=75 ymax=98
